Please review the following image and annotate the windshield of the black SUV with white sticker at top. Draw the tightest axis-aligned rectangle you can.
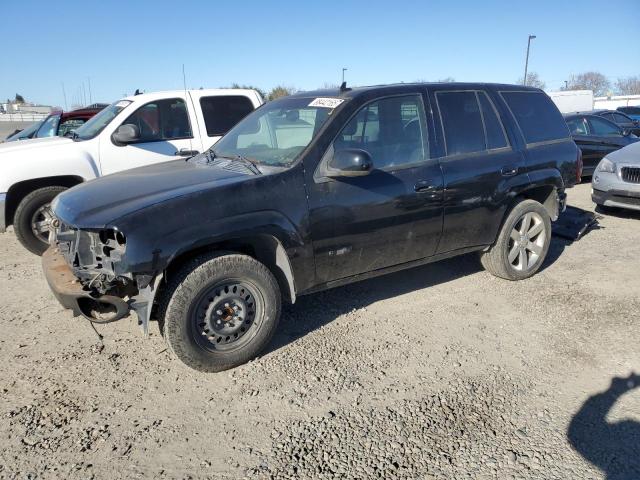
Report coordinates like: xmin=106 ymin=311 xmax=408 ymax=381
xmin=212 ymin=97 xmax=344 ymax=166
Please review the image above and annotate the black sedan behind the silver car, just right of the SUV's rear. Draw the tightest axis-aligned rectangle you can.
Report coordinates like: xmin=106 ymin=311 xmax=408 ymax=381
xmin=564 ymin=113 xmax=640 ymax=177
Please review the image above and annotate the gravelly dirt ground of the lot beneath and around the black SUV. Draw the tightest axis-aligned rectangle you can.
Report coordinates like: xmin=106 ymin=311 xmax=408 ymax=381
xmin=0 ymin=184 xmax=640 ymax=479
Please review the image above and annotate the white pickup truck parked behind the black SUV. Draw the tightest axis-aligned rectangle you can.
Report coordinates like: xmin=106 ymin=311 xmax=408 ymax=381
xmin=0 ymin=89 xmax=263 ymax=255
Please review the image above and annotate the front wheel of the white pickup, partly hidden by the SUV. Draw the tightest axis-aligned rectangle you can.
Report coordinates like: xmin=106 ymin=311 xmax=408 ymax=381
xmin=13 ymin=186 xmax=67 ymax=255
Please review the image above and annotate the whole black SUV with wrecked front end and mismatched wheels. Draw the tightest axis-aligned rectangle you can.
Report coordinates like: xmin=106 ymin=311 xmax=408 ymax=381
xmin=43 ymin=83 xmax=581 ymax=371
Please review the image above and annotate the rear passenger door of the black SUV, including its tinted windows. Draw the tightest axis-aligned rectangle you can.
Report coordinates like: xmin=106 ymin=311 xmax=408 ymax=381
xmin=432 ymin=87 xmax=528 ymax=253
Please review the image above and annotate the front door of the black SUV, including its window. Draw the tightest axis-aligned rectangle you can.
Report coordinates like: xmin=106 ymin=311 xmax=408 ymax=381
xmin=307 ymin=93 xmax=442 ymax=283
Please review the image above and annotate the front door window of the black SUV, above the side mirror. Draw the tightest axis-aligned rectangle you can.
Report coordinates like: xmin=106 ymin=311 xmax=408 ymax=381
xmin=333 ymin=95 xmax=428 ymax=169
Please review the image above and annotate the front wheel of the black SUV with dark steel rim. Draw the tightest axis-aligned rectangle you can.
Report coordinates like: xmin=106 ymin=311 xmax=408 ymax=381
xmin=159 ymin=253 xmax=281 ymax=372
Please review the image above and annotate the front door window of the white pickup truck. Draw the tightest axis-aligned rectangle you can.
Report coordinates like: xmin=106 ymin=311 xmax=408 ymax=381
xmin=123 ymin=98 xmax=191 ymax=143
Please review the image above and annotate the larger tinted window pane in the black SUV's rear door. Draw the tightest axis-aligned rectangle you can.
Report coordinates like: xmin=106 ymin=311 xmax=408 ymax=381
xmin=436 ymin=92 xmax=485 ymax=155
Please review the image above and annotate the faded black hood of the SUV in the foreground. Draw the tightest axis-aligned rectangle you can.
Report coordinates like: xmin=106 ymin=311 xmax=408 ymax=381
xmin=54 ymin=156 xmax=253 ymax=228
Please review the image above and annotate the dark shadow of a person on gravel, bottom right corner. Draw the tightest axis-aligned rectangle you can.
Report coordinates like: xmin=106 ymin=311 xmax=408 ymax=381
xmin=567 ymin=374 xmax=640 ymax=480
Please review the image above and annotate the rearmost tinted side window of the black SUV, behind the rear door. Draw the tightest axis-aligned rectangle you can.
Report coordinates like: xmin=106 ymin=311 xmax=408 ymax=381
xmin=501 ymin=92 xmax=569 ymax=143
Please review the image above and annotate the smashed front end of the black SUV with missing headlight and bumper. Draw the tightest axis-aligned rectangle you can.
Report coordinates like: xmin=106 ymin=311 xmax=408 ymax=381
xmin=42 ymin=219 xmax=161 ymax=336
